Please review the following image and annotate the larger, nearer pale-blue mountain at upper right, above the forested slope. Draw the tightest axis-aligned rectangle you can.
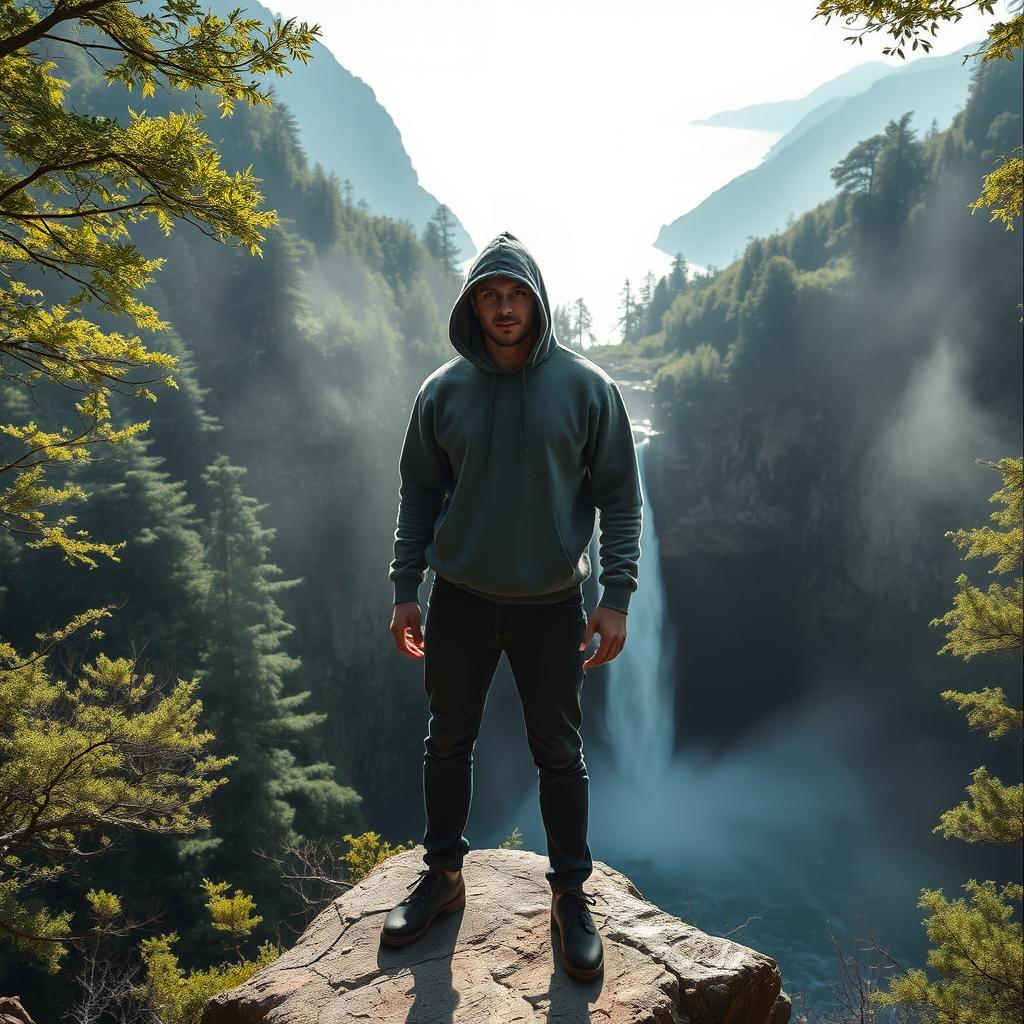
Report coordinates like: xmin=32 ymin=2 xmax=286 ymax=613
xmin=654 ymin=42 xmax=980 ymax=266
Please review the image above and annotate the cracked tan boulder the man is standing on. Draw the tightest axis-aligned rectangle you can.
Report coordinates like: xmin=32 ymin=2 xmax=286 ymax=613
xmin=203 ymin=847 xmax=791 ymax=1024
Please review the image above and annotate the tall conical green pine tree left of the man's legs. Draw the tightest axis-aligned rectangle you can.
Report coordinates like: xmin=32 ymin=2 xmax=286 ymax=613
xmin=189 ymin=456 xmax=359 ymax=916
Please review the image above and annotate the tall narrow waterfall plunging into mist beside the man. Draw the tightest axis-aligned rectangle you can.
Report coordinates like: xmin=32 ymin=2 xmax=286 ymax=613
xmin=592 ymin=437 xmax=675 ymax=778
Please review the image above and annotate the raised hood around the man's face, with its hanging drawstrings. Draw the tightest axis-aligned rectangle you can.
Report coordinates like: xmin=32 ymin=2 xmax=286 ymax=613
xmin=449 ymin=231 xmax=558 ymax=462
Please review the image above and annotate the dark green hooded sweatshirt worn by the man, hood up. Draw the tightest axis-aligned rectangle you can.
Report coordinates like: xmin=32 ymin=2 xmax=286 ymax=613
xmin=389 ymin=231 xmax=642 ymax=613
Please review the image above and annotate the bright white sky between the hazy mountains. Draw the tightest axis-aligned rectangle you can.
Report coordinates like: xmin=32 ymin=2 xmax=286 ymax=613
xmin=267 ymin=0 xmax=1006 ymax=340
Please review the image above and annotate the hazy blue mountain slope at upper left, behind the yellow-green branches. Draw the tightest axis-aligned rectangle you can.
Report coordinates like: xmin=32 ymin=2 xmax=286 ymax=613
xmin=210 ymin=0 xmax=476 ymax=259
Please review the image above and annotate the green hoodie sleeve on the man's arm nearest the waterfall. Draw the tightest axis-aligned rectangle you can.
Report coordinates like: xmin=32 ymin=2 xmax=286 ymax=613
xmin=588 ymin=381 xmax=643 ymax=613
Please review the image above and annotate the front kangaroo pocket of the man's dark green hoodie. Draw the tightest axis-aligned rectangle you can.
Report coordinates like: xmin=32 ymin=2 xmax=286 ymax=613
xmin=434 ymin=497 xmax=578 ymax=597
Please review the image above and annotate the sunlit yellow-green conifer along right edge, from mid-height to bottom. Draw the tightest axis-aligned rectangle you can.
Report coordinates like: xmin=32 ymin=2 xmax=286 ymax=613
xmin=871 ymin=459 xmax=1024 ymax=1024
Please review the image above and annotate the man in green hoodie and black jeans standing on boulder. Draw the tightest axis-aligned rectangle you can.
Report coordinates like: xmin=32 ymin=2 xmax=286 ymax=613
xmin=381 ymin=231 xmax=642 ymax=978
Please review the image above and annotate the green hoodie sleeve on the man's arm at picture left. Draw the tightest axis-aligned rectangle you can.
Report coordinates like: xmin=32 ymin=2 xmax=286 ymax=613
xmin=388 ymin=387 xmax=449 ymax=604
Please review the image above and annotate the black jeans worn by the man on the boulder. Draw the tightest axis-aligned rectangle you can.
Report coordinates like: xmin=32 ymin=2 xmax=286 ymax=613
xmin=423 ymin=575 xmax=594 ymax=889
